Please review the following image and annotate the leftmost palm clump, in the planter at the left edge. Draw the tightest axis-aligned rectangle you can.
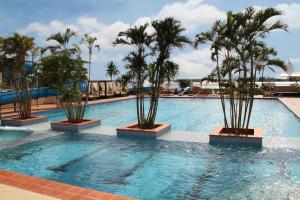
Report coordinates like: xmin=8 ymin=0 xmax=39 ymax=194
xmin=1 ymin=33 xmax=35 ymax=119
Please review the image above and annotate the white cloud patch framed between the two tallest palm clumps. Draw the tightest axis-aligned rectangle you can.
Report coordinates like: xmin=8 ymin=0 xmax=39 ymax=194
xmin=173 ymin=47 xmax=215 ymax=78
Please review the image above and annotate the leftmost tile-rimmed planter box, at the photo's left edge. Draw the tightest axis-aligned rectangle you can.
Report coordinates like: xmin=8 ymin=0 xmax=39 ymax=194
xmin=1 ymin=116 xmax=48 ymax=126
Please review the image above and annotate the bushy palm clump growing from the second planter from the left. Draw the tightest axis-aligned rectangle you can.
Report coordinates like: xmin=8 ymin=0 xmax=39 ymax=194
xmin=40 ymin=29 xmax=87 ymax=123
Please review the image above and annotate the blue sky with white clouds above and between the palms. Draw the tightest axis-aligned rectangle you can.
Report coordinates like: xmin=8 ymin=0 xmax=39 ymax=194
xmin=0 ymin=0 xmax=300 ymax=80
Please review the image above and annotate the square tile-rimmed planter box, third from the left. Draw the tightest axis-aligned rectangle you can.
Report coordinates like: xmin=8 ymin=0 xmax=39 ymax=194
xmin=117 ymin=124 xmax=171 ymax=139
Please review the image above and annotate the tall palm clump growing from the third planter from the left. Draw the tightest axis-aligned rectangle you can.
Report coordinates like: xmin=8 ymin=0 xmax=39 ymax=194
xmin=114 ymin=17 xmax=190 ymax=128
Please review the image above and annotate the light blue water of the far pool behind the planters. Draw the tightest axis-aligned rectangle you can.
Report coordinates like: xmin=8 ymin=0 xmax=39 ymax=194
xmin=41 ymin=98 xmax=300 ymax=136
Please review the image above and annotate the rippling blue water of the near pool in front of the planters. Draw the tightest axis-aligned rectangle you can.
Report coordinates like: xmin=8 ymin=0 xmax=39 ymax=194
xmin=0 ymin=134 xmax=300 ymax=200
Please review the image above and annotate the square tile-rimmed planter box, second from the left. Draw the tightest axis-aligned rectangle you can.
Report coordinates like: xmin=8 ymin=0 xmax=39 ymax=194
xmin=51 ymin=119 xmax=101 ymax=132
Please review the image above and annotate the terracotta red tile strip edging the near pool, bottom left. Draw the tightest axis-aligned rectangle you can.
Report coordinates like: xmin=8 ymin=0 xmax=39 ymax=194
xmin=0 ymin=170 xmax=134 ymax=200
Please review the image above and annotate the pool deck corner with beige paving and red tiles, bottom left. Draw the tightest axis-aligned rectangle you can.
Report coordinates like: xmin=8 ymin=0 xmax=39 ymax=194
xmin=0 ymin=170 xmax=134 ymax=200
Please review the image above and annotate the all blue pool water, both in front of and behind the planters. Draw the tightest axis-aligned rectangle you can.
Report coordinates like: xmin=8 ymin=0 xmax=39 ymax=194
xmin=0 ymin=99 xmax=300 ymax=200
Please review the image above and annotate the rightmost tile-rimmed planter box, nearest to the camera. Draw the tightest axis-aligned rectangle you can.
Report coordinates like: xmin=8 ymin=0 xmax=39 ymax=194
xmin=209 ymin=127 xmax=263 ymax=147
